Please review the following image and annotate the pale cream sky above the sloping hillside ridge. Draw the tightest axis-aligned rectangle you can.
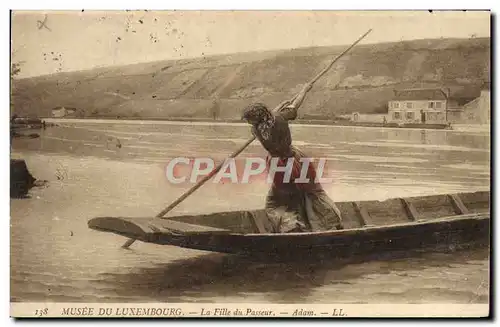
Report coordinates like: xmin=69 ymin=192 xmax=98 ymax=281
xmin=12 ymin=11 xmax=490 ymax=77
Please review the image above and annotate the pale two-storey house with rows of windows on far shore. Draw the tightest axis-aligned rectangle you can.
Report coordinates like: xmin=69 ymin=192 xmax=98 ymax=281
xmin=388 ymin=88 xmax=448 ymax=124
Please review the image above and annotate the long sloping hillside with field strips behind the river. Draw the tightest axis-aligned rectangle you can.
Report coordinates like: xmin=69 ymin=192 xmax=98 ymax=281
xmin=12 ymin=38 xmax=490 ymax=119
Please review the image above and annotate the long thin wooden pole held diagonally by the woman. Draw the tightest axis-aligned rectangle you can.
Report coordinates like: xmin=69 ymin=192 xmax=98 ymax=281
xmin=122 ymin=29 xmax=372 ymax=248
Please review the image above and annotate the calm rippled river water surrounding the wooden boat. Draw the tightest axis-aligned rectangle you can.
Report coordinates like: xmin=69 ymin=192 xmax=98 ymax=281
xmin=11 ymin=122 xmax=490 ymax=303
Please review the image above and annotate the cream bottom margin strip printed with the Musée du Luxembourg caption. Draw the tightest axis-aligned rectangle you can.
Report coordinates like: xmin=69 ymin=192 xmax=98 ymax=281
xmin=10 ymin=302 xmax=489 ymax=318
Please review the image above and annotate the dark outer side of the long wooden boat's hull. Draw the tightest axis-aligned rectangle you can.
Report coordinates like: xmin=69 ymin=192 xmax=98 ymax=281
xmin=90 ymin=214 xmax=490 ymax=258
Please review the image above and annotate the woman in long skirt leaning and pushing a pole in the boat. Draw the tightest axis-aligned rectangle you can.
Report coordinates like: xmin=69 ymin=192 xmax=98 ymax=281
xmin=242 ymin=84 xmax=342 ymax=233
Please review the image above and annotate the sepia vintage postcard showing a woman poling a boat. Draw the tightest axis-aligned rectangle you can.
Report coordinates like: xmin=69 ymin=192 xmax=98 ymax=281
xmin=10 ymin=10 xmax=491 ymax=318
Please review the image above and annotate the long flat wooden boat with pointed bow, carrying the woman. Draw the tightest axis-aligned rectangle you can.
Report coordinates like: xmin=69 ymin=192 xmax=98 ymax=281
xmin=88 ymin=191 xmax=490 ymax=258
